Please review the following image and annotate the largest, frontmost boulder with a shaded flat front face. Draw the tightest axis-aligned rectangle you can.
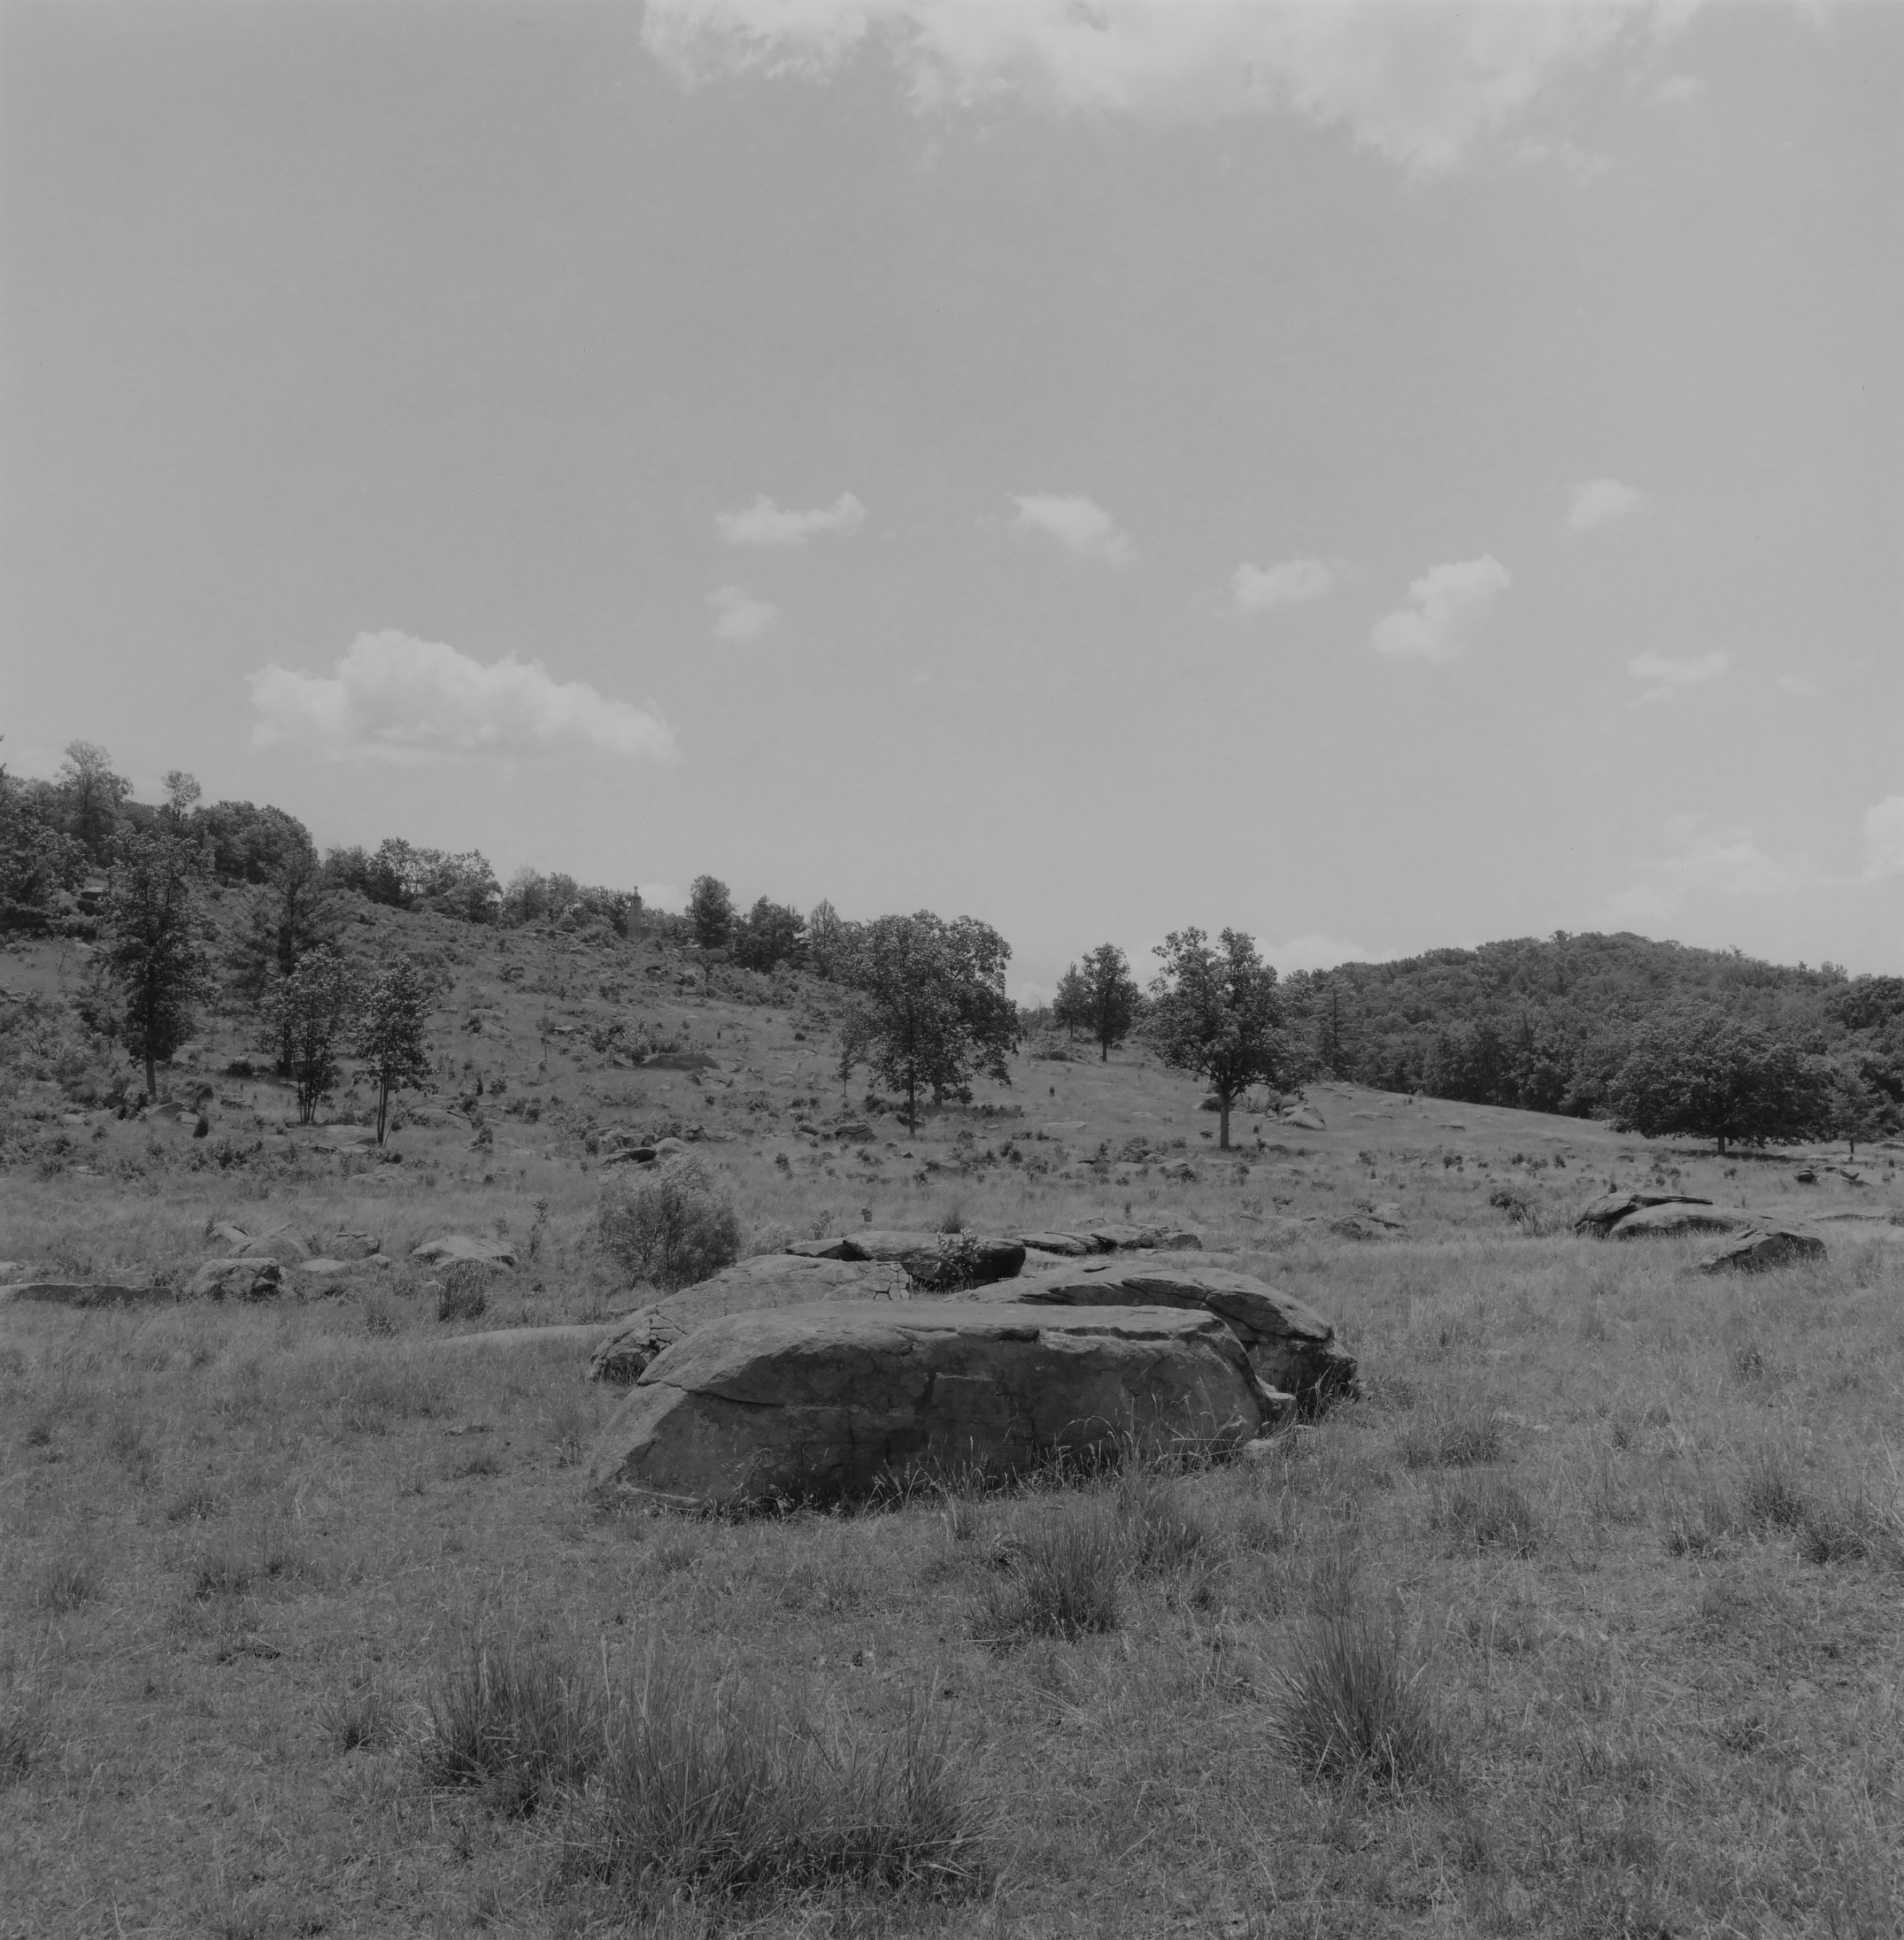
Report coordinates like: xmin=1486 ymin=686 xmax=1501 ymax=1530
xmin=588 ymin=1302 xmax=1279 ymax=1509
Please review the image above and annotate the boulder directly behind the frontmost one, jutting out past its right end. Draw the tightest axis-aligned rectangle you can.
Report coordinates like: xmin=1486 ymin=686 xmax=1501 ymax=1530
xmin=988 ymin=1259 xmax=1354 ymax=1414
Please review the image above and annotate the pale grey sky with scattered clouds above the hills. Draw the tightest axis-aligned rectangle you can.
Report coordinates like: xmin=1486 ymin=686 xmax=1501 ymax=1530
xmin=0 ymin=0 xmax=1904 ymax=997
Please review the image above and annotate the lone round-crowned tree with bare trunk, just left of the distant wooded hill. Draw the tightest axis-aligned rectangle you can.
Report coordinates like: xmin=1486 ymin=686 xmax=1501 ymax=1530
xmin=1149 ymin=929 xmax=1307 ymax=1151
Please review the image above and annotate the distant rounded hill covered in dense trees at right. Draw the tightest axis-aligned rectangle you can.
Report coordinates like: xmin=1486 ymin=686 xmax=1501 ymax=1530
xmin=1285 ymin=931 xmax=1904 ymax=1118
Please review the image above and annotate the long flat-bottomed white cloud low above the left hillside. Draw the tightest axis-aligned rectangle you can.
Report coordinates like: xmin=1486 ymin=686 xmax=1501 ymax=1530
xmin=251 ymin=633 xmax=675 ymax=760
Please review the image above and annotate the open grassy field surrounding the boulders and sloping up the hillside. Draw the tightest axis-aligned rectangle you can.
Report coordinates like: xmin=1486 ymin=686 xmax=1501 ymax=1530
xmin=0 ymin=926 xmax=1904 ymax=1940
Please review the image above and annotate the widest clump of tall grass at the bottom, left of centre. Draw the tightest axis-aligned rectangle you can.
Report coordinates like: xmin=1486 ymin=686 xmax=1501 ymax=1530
xmin=573 ymin=1655 xmax=990 ymax=1901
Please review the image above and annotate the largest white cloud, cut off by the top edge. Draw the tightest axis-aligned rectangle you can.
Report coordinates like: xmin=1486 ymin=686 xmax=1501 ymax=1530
xmin=643 ymin=0 xmax=1700 ymax=174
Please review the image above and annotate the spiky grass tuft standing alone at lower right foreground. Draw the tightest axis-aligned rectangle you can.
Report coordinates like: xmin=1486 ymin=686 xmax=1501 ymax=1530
xmin=1273 ymin=1595 xmax=1452 ymax=1792
